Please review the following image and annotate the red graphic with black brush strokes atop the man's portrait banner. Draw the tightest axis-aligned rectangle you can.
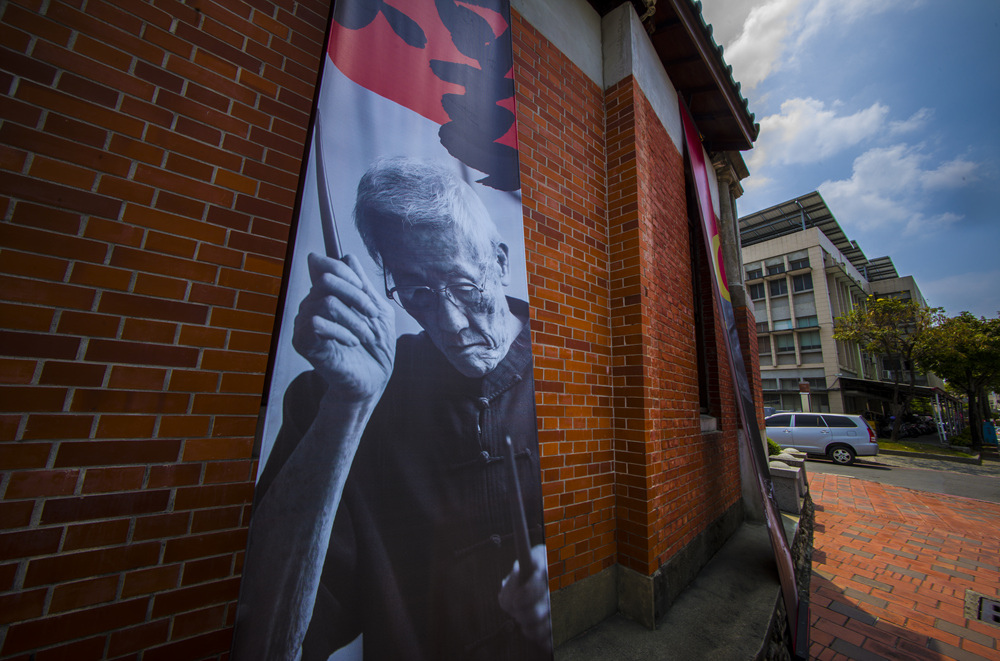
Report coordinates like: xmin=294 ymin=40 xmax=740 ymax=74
xmin=328 ymin=0 xmax=520 ymax=190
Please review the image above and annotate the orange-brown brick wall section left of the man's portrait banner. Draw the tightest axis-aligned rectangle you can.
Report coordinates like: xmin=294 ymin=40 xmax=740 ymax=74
xmin=0 ymin=0 xmax=329 ymax=659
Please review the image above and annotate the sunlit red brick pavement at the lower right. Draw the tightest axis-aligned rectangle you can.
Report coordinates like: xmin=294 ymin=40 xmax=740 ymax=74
xmin=809 ymin=474 xmax=1000 ymax=661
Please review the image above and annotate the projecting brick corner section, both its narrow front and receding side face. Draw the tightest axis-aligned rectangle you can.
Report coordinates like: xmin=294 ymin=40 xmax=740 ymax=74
xmin=608 ymin=78 xmax=740 ymax=574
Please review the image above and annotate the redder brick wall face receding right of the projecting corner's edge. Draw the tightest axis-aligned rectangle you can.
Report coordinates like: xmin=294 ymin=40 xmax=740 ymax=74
xmin=634 ymin=87 xmax=740 ymax=573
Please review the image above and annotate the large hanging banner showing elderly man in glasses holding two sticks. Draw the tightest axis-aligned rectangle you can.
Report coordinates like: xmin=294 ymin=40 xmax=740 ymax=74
xmin=233 ymin=0 xmax=552 ymax=661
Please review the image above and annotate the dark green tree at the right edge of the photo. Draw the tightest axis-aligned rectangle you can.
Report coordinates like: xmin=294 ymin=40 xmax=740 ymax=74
xmin=920 ymin=312 xmax=1000 ymax=452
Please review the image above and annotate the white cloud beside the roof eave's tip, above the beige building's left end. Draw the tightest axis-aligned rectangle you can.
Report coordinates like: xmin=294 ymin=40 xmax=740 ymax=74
xmin=747 ymin=99 xmax=889 ymax=171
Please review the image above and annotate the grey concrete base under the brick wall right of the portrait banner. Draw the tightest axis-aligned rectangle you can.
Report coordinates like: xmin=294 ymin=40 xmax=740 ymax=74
xmin=552 ymin=502 xmax=743 ymax=645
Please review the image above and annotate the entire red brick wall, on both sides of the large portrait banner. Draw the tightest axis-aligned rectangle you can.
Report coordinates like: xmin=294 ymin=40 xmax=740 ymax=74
xmin=0 ymin=0 xmax=752 ymax=660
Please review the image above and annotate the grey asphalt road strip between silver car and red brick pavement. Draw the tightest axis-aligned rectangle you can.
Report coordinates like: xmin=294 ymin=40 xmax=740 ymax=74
xmin=806 ymin=455 xmax=1000 ymax=503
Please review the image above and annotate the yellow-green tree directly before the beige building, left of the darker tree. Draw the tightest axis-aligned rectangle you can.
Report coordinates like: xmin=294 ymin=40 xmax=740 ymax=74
xmin=833 ymin=296 xmax=940 ymax=441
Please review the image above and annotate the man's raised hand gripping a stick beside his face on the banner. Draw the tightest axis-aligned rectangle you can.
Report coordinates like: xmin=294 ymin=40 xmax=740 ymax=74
xmin=292 ymin=253 xmax=396 ymax=401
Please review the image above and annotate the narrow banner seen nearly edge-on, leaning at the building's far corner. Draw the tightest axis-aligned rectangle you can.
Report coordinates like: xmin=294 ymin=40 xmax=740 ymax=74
xmin=680 ymin=101 xmax=809 ymax=659
